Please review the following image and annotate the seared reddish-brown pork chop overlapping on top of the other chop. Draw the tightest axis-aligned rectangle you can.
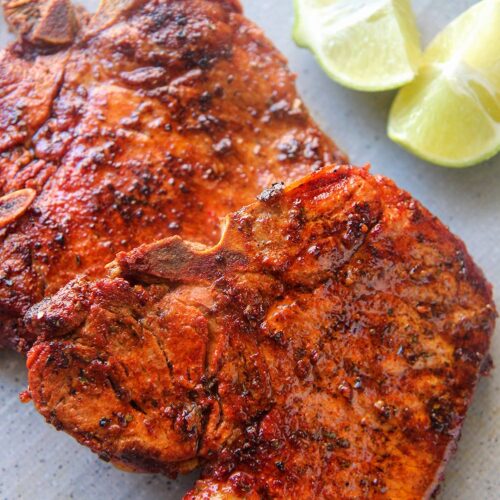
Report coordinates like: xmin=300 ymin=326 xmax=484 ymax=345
xmin=26 ymin=167 xmax=496 ymax=500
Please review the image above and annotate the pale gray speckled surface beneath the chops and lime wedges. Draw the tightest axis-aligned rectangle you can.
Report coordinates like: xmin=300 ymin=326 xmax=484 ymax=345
xmin=0 ymin=0 xmax=500 ymax=500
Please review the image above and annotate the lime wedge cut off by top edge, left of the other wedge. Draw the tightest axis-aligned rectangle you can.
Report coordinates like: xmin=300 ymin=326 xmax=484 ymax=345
xmin=293 ymin=0 xmax=421 ymax=91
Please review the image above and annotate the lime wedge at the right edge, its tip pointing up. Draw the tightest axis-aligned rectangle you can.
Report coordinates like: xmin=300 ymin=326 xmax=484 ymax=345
xmin=388 ymin=0 xmax=500 ymax=167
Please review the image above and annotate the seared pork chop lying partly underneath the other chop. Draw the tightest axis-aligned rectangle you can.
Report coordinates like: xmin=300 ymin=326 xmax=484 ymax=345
xmin=0 ymin=0 xmax=342 ymax=348
